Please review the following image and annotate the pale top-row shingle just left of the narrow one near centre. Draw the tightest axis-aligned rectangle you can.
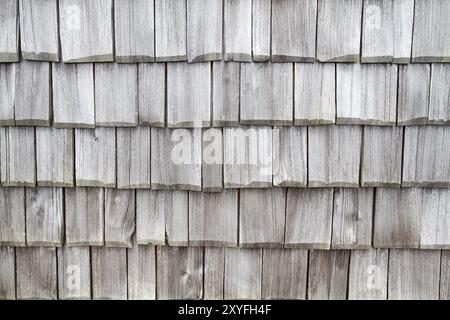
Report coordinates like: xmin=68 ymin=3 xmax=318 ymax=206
xmin=223 ymin=0 xmax=252 ymax=62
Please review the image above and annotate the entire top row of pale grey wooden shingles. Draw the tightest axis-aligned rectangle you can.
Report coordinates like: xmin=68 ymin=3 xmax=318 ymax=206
xmin=0 ymin=0 xmax=450 ymax=63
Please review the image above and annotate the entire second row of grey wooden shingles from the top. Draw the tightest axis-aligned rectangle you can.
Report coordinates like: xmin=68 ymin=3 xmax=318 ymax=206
xmin=0 ymin=61 xmax=450 ymax=128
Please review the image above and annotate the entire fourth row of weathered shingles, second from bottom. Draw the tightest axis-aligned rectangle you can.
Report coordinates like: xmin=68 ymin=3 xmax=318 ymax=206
xmin=0 ymin=188 xmax=450 ymax=249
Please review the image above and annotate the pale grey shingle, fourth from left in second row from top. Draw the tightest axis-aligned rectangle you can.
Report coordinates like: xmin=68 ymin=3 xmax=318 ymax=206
xmin=95 ymin=63 xmax=138 ymax=127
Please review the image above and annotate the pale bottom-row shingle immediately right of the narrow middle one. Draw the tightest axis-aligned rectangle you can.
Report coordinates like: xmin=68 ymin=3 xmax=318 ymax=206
xmin=223 ymin=248 xmax=262 ymax=300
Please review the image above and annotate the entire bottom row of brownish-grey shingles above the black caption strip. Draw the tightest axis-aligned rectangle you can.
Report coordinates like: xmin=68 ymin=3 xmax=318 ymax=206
xmin=0 ymin=245 xmax=450 ymax=300
